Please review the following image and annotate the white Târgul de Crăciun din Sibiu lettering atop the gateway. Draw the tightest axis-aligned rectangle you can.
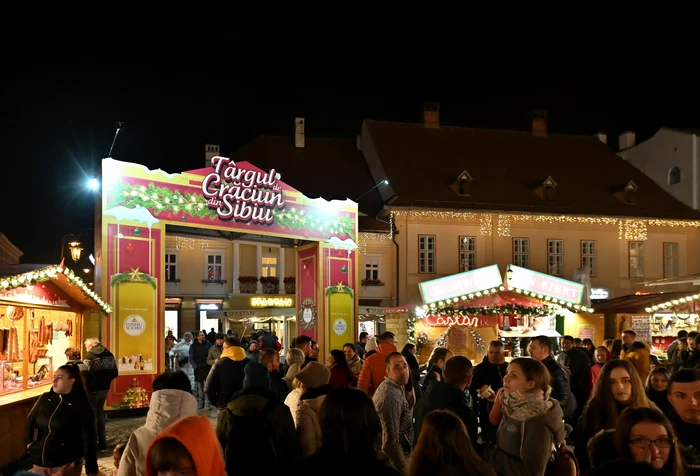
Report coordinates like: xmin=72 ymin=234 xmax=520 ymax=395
xmin=201 ymin=157 xmax=285 ymax=225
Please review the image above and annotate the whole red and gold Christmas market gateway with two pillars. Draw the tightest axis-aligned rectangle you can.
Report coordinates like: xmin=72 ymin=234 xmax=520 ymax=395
xmin=95 ymin=157 xmax=358 ymax=403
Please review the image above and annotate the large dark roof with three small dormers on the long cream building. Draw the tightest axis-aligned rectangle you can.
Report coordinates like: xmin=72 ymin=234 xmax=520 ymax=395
xmin=362 ymin=120 xmax=700 ymax=220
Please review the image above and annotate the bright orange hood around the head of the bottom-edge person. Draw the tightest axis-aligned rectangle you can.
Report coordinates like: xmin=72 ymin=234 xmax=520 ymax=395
xmin=145 ymin=416 xmax=226 ymax=476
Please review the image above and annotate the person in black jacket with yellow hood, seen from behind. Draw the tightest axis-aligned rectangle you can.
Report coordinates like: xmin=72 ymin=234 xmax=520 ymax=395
xmin=207 ymin=337 xmax=249 ymax=413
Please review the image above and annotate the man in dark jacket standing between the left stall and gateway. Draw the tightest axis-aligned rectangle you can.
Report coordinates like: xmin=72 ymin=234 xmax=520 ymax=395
xmin=83 ymin=337 xmax=119 ymax=450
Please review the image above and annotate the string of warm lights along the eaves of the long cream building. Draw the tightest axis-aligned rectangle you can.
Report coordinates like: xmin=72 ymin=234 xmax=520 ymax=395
xmin=391 ymin=210 xmax=700 ymax=241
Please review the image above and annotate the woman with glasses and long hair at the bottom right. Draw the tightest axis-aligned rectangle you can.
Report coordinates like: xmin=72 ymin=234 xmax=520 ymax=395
xmin=588 ymin=407 xmax=686 ymax=476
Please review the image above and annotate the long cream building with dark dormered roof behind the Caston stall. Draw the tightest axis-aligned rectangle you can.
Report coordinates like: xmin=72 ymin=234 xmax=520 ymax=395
xmin=360 ymin=108 xmax=700 ymax=314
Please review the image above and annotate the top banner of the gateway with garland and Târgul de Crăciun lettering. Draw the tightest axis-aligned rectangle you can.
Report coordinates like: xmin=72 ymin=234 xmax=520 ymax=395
xmin=102 ymin=157 xmax=357 ymax=246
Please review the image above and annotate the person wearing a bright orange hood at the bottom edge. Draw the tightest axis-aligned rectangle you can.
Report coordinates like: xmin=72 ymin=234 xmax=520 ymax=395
xmin=146 ymin=416 xmax=226 ymax=476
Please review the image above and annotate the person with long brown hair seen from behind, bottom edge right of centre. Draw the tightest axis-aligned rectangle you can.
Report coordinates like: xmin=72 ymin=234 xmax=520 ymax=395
xmin=408 ymin=410 xmax=496 ymax=476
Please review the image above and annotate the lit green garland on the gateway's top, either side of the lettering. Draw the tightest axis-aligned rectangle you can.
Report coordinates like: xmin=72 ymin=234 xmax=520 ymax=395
xmin=109 ymin=183 xmax=355 ymax=237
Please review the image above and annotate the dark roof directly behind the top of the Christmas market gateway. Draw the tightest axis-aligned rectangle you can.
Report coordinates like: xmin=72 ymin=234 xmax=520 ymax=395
xmin=232 ymin=136 xmax=384 ymax=217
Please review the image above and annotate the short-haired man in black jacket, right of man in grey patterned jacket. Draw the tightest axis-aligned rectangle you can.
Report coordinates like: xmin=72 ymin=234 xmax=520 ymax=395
xmin=413 ymin=355 xmax=479 ymax=448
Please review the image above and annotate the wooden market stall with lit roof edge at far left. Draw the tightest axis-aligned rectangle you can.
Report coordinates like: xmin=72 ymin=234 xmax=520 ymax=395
xmin=0 ymin=265 xmax=111 ymax=467
